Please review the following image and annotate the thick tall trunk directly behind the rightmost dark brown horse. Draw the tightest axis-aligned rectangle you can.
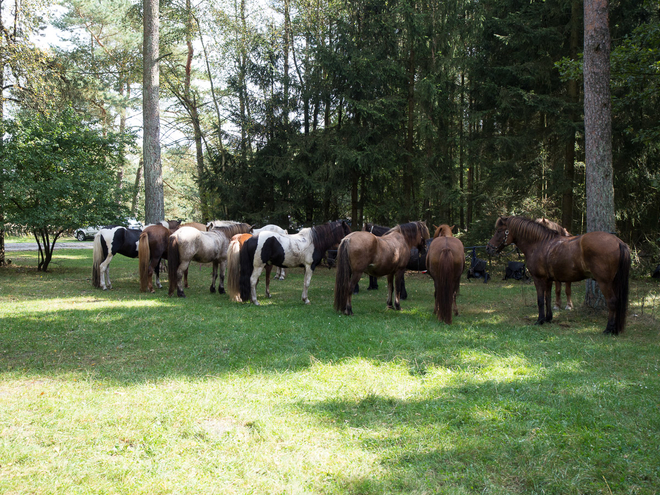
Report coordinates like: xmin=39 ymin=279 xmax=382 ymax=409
xmin=584 ymin=0 xmax=615 ymax=307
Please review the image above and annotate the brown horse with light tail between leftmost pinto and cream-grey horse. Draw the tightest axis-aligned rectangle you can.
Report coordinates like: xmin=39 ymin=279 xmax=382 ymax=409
xmin=138 ymin=222 xmax=180 ymax=293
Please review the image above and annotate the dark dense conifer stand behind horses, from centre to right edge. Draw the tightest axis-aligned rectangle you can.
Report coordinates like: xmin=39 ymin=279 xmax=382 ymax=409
xmin=202 ymin=0 xmax=660 ymax=248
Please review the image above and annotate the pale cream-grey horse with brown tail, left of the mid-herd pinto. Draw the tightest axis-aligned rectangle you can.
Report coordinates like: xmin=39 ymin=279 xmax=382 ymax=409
xmin=167 ymin=222 xmax=252 ymax=297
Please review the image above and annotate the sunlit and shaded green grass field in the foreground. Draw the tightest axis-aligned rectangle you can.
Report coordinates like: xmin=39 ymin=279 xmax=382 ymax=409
xmin=0 ymin=250 xmax=660 ymax=494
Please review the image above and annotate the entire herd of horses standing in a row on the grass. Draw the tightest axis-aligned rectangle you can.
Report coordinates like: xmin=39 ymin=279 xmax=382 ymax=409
xmin=92 ymin=216 xmax=631 ymax=335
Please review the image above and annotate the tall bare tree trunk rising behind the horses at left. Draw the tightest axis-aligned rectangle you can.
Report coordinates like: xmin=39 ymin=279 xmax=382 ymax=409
xmin=142 ymin=0 xmax=165 ymax=223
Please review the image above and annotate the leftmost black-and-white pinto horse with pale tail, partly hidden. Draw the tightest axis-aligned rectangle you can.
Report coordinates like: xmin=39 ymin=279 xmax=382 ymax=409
xmin=92 ymin=220 xmax=181 ymax=290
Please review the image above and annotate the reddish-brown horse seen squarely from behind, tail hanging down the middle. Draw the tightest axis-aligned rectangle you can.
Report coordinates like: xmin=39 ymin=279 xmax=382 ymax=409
xmin=426 ymin=224 xmax=465 ymax=325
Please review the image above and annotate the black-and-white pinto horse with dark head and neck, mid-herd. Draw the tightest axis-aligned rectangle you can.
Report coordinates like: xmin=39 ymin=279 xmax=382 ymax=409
xmin=240 ymin=220 xmax=351 ymax=306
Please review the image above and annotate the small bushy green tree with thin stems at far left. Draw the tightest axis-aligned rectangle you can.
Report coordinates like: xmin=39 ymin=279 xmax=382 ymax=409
xmin=0 ymin=109 xmax=134 ymax=271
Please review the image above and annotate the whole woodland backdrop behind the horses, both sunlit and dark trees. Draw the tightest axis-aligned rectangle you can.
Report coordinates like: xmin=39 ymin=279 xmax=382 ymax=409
xmin=0 ymin=0 xmax=660 ymax=252
